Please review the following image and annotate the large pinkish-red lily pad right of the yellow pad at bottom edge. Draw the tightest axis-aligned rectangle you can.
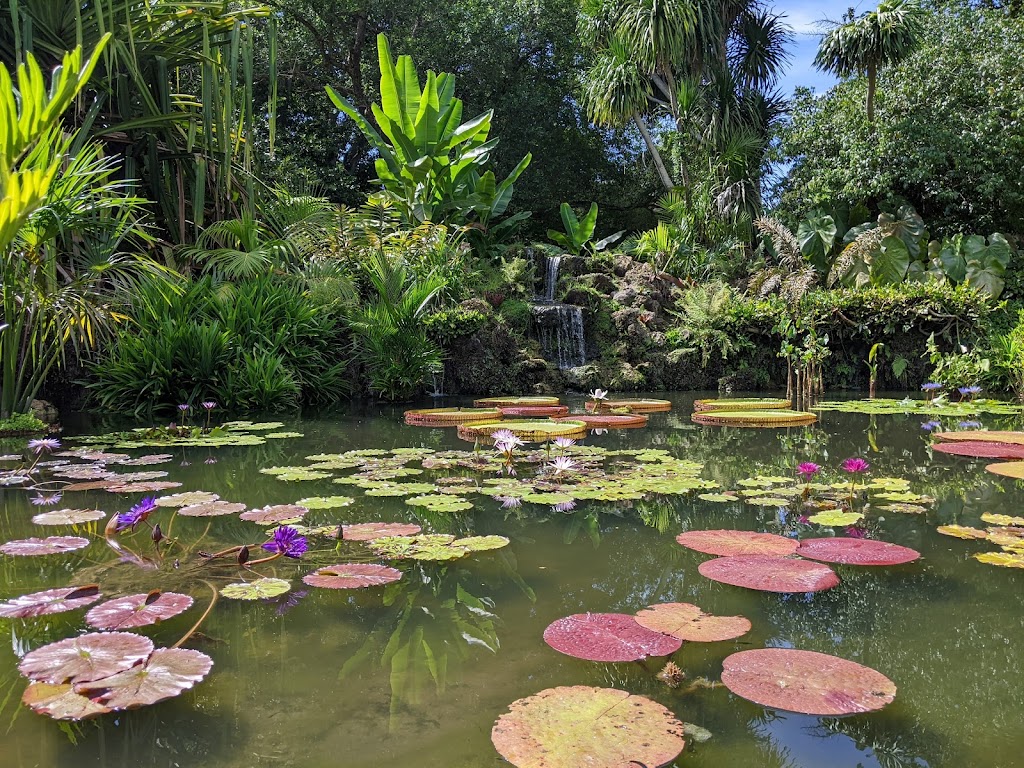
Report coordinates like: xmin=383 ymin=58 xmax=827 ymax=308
xmin=722 ymin=648 xmax=896 ymax=716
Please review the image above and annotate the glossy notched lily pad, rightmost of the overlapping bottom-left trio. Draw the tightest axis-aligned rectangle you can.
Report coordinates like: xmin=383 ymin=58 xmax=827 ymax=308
xmin=76 ymin=648 xmax=213 ymax=710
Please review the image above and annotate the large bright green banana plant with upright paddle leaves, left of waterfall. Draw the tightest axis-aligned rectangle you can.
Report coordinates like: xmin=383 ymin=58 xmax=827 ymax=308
xmin=327 ymin=35 xmax=530 ymax=223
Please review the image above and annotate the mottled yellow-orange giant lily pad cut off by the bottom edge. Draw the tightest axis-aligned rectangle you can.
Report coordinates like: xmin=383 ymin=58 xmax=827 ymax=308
xmin=490 ymin=685 xmax=686 ymax=768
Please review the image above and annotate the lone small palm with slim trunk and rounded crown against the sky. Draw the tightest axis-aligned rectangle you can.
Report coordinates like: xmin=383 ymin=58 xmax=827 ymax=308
xmin=814 ymin=0 xmax=924 ymax=123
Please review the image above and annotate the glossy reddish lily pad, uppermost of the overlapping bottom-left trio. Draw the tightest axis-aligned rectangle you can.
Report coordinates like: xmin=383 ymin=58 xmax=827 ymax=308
xmin=17 ymin=632 xmax=153 ymax=685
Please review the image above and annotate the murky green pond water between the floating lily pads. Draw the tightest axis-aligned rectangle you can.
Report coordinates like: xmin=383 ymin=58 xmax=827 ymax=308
xmin=0 ymin=393 xmax=1024 ymax=768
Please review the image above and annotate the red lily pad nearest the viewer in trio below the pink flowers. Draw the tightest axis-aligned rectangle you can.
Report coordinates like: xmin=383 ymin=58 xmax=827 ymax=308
xmin=697 ymin=555 xmax=839 ymax=592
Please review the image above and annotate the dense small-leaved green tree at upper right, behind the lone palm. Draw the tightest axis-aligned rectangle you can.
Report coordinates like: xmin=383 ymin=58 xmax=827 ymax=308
xmin=780 ymin=1 xmax=1024 ymax=237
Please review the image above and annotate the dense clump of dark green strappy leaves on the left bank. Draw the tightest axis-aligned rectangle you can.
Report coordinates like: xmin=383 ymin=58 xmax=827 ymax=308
xmin=87 ymin=276 xmax=347 ymax=413
